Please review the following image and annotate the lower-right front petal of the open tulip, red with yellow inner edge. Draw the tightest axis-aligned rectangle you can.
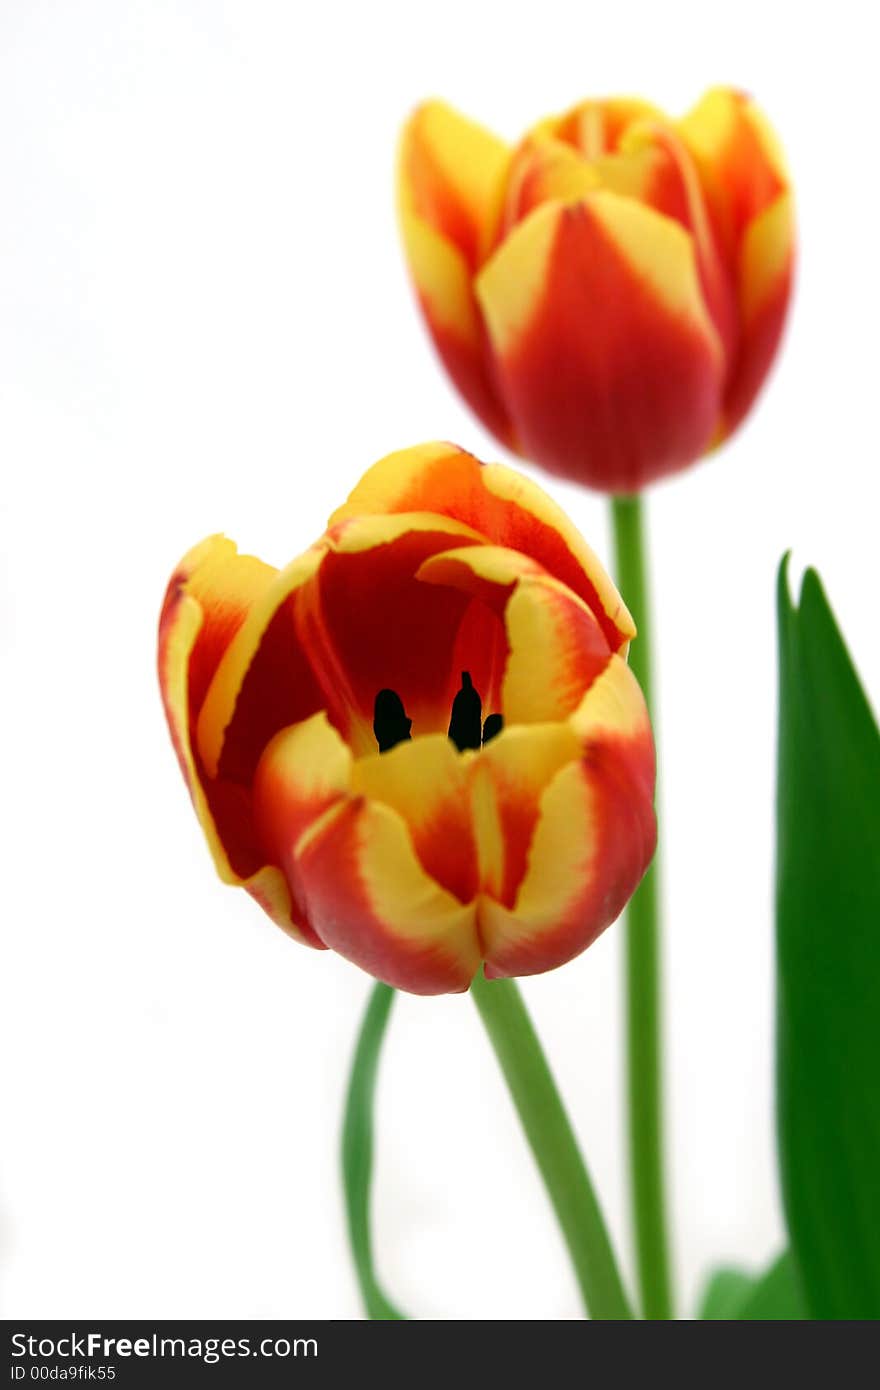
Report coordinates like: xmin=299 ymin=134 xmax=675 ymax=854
xmin=478 ymin=657 xmax=656 ymax=979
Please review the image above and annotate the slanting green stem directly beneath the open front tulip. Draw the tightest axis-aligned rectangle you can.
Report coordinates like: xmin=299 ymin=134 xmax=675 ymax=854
xmin=470 ymin=972 xmax=633 ymax=1321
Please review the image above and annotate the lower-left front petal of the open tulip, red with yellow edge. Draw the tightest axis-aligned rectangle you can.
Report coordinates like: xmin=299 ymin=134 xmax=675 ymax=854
xmin=296 ymin=798 xmax=480 ymax=994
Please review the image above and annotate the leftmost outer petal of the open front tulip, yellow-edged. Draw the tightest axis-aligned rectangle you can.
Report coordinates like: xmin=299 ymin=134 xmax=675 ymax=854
xmin=158 ymin=537 xmax=304 ymax=937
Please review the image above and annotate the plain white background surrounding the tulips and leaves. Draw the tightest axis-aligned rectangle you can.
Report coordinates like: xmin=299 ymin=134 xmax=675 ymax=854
xmin=0 ymin=0 xmax=880 ymax=1318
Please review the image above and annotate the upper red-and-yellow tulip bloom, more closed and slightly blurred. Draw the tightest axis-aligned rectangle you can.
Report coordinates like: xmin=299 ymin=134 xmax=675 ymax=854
xmin=399 ymin=89 xmax=794 ymax=493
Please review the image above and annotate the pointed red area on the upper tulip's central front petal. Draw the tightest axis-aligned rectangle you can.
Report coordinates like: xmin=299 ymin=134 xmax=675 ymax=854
xmin=486 ymin=203 xmax=722 ymax=492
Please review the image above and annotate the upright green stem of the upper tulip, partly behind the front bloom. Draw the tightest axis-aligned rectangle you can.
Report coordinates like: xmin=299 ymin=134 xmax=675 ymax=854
xmin=612 ymin=495 xmax=673 ymax=1319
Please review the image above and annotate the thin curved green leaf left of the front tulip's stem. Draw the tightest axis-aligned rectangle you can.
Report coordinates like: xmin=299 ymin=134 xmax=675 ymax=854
xmin=342 ymin=984 xmax=406 ymax=1321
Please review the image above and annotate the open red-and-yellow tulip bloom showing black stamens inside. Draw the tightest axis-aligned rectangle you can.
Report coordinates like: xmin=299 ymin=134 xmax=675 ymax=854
xmin=158 ymin=445 xmax=655 ymax=994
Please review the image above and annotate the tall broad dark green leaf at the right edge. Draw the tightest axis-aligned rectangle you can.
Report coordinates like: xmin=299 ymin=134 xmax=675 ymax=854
xmin=776 ymin=562 xmax=880 ymax=1319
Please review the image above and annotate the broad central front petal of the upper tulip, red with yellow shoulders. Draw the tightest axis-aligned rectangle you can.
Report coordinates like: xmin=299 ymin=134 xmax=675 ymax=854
xmin=477 ymin=192 xmax=724 ymax=493
